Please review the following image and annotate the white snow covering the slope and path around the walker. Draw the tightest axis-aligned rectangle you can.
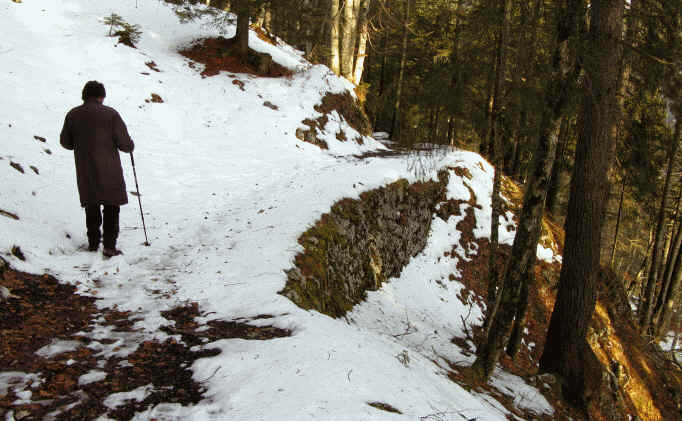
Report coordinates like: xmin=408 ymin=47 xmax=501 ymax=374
xmin=0 ymin=0 xmax=552 ymax=420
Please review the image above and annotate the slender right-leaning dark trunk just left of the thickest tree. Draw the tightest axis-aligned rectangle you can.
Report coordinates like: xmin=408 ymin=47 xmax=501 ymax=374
xmin=472 ymin=0 xmax=583 ymax=379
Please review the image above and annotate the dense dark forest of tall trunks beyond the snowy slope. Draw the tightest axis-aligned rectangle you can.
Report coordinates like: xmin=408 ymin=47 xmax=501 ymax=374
xmin=169 ymin=0 xmax=682 ymax=406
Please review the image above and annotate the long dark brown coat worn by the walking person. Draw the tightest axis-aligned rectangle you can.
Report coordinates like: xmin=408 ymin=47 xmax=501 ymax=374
xmin=60 ymin=99 xmax=135 ymax=206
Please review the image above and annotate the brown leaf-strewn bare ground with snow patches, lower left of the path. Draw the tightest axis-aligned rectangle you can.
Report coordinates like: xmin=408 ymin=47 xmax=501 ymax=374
xmin=0 ymin=260 xmax=291 ymax=421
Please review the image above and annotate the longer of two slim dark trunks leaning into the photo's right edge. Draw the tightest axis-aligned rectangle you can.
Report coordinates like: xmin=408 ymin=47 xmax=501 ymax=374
xmin=638 ymin=120 xmax=680 ymax=334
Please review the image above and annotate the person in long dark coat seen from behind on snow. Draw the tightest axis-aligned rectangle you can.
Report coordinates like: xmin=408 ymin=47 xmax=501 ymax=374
xmin=60 ymin=80 xmax=135 ymax=258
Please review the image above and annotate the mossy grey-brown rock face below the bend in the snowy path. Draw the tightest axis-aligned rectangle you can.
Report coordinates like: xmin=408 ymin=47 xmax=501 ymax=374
xmin=280 ymin=171 xmax=449 ymax=317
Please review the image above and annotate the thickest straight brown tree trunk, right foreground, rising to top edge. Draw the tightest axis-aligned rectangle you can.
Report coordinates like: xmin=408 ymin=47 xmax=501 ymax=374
xmin=540 ymin=0 xmax=624 ymax=405
